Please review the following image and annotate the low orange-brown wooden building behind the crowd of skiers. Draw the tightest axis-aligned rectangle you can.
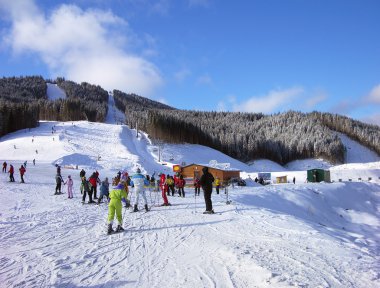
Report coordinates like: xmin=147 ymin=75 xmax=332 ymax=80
xmin=181 ymin=164 xmax=240 ymax=182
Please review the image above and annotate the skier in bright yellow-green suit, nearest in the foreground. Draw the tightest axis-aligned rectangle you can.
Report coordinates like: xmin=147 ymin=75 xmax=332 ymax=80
xmin=107 ymin=183 xmax=127 ymax=234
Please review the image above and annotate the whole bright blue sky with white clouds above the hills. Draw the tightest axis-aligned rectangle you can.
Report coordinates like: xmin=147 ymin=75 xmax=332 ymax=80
xmin=0 ymin=0 xmax=380 ymax=125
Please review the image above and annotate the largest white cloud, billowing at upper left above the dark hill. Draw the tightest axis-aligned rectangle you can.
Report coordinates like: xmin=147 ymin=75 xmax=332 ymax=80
xmin=0 ymin=0 xmax=163 ymax=96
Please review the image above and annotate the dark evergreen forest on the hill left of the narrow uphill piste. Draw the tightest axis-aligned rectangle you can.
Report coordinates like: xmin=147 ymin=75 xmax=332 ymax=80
xmin=0 ymin=76 xmax=108 ymax=135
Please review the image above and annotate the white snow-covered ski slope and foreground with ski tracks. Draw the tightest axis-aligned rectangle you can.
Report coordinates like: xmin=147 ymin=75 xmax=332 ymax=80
xmin=0 ymin=89 xmax=380 ymax=288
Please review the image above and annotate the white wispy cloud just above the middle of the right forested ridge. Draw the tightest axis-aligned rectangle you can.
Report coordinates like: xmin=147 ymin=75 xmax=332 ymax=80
xmin=233 ymin=87 xmax=304 ymax=113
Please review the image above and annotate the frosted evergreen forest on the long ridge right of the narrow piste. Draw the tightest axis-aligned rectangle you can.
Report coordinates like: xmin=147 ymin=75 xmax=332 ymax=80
xmin=114 ymin=90 xmax=380 ymax=164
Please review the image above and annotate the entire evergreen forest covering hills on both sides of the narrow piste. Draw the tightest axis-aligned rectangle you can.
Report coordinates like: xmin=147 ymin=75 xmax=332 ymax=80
xmin=0 ymin=76 xmax=380 ymax=164
